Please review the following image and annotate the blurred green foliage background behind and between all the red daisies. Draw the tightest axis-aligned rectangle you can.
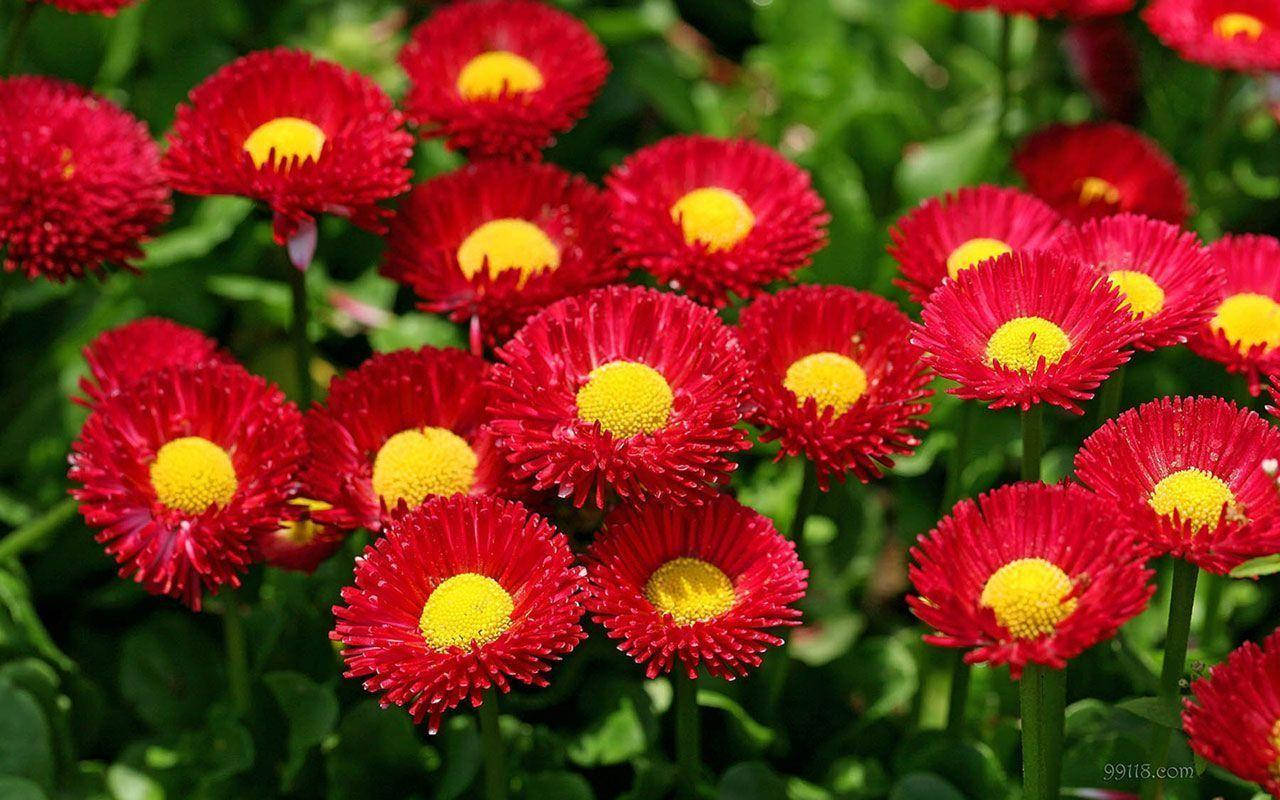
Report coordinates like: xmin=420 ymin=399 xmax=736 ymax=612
xmin=0 ymin=0 xmax=1280 ymax=800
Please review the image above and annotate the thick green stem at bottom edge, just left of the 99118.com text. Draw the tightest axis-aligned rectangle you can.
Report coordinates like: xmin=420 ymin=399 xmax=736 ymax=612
xmin=1019 ymin=664 xmax=1066 ymax=800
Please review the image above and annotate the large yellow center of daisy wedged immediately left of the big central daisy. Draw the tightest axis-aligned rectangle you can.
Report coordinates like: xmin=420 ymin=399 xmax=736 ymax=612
xmin=374 ymin=428 xmax=477 ymax=508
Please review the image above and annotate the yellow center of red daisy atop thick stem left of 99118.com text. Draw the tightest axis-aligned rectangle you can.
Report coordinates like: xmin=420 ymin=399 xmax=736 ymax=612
xmin=978 ymin=558 xmax=1075 ymax=639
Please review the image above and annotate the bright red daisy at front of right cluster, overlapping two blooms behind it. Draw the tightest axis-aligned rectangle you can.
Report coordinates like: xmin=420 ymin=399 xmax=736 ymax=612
xmin=913 ymin=252 xmax=1139 ymax=413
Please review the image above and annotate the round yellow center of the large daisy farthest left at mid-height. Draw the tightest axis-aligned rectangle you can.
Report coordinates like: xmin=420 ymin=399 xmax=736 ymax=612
xmin=151 ymin=436 xmax=237 ymax=513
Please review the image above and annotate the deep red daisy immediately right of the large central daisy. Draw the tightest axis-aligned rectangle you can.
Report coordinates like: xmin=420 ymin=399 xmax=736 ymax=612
xmin=737 ymin=285 xmax=929 ymax=489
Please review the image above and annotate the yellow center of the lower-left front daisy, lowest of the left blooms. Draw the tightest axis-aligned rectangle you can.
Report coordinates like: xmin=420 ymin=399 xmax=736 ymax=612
xmin=417 ymin=572 xmax=516 ymax=650
